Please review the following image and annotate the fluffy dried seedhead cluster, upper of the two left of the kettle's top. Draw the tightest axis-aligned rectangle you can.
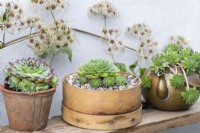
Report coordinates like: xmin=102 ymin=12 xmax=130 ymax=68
xmin=128 ymin=23 xmax=151 ymax=39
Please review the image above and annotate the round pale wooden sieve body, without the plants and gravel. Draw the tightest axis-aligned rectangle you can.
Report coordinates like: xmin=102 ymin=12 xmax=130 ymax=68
xmin=62 ymin=72 xmax=142 ymax=130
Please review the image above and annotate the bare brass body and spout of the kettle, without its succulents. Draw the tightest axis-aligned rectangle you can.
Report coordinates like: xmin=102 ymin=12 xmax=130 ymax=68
xmin=142 ymin=72 xmax=190 ymax=111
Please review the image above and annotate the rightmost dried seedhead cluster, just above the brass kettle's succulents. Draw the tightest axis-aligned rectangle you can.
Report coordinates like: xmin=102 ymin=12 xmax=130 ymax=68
xmin=169 ymin=36 xmax=188 ymax=46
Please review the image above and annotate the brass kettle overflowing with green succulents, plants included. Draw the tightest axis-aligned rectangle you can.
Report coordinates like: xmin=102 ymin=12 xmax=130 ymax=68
xmin=142 ymin=44 xmax=200 ymax=110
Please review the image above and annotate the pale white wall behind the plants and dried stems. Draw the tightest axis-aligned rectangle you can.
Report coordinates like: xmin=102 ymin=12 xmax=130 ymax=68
xmin=0 ymin=0 xmax=200 ymax=131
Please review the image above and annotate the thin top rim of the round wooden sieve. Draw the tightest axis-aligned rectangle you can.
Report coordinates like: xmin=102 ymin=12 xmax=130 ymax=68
xmin=63 ymin=72 xmax=142 ymax=93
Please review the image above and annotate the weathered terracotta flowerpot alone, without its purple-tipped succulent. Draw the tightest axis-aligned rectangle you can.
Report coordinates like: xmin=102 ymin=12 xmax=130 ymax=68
xmin=0 ymin=86 xmax=56 ymax=131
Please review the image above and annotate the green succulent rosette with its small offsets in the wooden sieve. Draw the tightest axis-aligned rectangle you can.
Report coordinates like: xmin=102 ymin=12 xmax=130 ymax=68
xmin=76 ymin=59 xmax=130 ymax=88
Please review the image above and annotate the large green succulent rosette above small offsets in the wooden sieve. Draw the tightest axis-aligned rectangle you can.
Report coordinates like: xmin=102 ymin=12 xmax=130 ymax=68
xmin=78 ymin=59 xmax=119 ymax=79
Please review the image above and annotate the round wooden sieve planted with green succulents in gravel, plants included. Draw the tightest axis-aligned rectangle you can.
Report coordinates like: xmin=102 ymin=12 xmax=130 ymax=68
xmin=62 ymin=59 xmax=141 ymax=130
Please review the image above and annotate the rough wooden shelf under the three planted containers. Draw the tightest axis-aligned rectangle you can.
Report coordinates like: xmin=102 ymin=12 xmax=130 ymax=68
xmin=0 ymin=100 xmax=200 ymax=133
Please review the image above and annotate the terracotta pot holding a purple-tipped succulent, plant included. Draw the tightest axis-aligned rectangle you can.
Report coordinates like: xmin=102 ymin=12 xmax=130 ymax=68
xmin=0 ymin=58 xmax=57 ymax=131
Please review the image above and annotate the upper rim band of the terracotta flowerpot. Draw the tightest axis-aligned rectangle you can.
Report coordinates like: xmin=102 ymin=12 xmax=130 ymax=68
xmin=0 ymin=85 xmax=56 ymax=96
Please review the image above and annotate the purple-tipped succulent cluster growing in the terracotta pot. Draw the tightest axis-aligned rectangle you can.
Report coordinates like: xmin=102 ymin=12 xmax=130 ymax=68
xmin=4 ymin=58 xmax=58 ymax=92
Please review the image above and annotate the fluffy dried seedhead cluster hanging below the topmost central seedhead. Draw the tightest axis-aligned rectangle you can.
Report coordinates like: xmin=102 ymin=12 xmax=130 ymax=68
xmin=102 ymin=28 xmax=125 ymax=54
